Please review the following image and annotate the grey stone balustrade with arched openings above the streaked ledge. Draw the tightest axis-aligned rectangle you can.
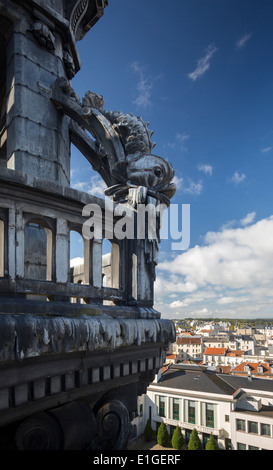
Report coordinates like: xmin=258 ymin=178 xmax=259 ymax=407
xmin=0 ymin=170 xmax=159 ymax=308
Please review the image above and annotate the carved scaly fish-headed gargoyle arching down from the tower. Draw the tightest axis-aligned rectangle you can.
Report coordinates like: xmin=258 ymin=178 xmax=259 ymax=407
xmin=51 ymin=78 xmax=176 ymax=206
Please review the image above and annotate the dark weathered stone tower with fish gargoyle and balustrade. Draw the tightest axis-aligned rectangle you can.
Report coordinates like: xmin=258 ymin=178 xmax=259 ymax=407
xmin=0 ymin=0 xmax=175 ymax=450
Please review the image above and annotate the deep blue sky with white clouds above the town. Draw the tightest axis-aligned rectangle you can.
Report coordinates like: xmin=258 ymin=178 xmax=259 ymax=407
xmin=71 ymin=0 xmax=273 ymax=319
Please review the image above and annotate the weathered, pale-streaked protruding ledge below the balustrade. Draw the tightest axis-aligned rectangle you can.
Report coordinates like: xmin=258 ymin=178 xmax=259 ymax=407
xmin=0 ymin=314 xmax=175 ymax=361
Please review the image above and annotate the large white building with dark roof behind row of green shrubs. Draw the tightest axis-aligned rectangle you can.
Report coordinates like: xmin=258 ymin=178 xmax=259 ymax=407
xmin=134 ymin=364 xmax=273 ymax=450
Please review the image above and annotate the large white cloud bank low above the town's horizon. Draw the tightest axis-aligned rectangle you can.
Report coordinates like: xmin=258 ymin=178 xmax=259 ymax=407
xmin=155 ymin=216 xmax=273 ymax=318
